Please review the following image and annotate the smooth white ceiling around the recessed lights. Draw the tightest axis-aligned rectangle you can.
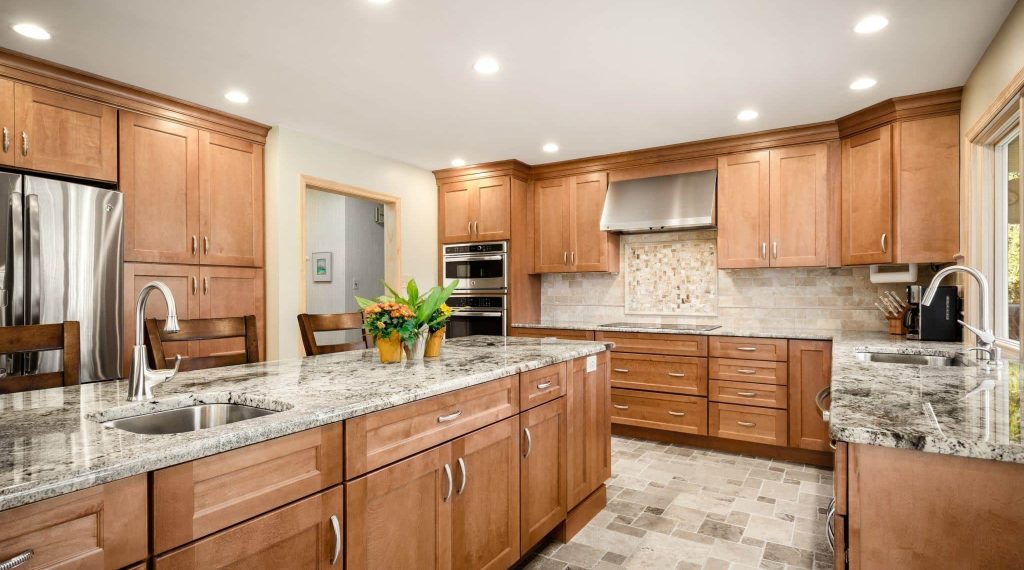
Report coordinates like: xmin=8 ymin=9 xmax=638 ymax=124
xmin=0 ymin=0 xmax=1014 ymax=169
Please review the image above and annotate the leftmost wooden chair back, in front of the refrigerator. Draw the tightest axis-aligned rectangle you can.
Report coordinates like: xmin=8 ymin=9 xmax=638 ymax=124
xmin=0 ymin=320 xmax=82 ymax=394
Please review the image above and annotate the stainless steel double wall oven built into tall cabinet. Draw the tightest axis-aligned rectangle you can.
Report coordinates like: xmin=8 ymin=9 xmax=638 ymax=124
xmin=443 ymin=242 xmax=508 ymax=339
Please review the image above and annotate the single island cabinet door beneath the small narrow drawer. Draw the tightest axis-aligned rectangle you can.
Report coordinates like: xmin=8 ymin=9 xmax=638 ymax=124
xmin=519 ymin=398 xmax=568 ymax=553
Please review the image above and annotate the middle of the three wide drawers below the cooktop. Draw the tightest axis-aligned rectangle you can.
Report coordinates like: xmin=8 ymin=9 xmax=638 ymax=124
xmin=611 ymin=353 xmax=708 ymax=396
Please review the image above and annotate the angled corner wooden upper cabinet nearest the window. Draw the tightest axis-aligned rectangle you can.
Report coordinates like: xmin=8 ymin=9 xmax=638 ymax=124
xmin=842 ymin=115 xmax=959 ymax=265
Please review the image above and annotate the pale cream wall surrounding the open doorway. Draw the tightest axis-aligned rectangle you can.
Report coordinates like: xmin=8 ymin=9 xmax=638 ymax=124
xmin=266 ymin=127 xmax=437 ymax=360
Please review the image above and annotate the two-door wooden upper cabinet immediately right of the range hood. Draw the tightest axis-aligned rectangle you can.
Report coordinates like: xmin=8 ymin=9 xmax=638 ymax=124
xmin=718 ymin=143 xmax=828 ymax=269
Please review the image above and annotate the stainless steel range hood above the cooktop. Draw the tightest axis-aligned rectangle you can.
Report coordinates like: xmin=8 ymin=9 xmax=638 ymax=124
xmin=601 ymin=170 xmax=718 ymax=233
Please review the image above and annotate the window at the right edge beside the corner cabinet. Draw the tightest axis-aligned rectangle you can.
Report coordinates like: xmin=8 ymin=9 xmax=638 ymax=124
xmin=994 ymin=128 xmax=1021 ymax=342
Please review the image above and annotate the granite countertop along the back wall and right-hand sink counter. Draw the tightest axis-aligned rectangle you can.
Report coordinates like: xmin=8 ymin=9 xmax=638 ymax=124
xmin=513 ymin=321 xmax=1024 ymax=464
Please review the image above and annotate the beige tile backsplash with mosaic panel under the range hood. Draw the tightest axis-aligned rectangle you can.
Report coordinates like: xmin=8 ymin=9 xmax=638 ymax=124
xmin=541 ymin=230 xmax=933 ymax=331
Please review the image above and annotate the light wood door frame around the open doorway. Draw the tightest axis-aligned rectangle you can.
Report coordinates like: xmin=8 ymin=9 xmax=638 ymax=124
xmin=297 ymin=174 xmax=401 ymax=313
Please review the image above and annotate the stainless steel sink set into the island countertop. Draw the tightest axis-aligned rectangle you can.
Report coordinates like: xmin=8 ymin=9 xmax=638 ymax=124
xmin=103 ymin=404 xmax=276 ymax=435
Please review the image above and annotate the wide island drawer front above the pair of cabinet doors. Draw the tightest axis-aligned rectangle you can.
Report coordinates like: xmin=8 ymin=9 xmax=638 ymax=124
xmin=345 ymin=375 xmax=519 ymax=479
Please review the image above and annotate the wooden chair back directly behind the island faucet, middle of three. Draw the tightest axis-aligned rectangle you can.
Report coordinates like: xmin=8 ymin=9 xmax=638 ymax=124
xmin=145 ymin=315 xmax=259 ymax=370
